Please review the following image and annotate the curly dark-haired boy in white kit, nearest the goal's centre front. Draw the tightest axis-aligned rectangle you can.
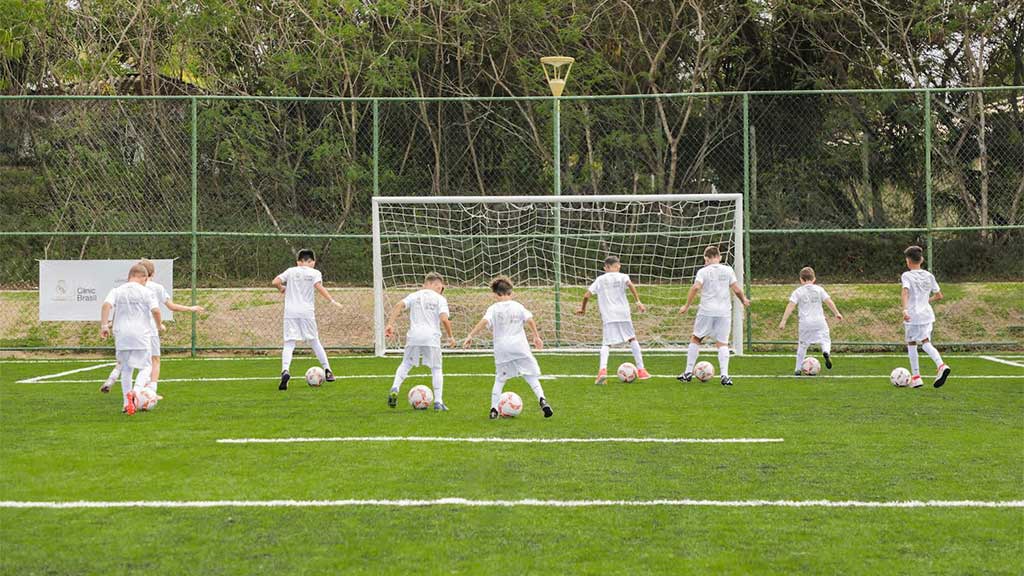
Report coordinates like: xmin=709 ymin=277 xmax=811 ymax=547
xmin=462 ymin=277 xmax=554 ymax=420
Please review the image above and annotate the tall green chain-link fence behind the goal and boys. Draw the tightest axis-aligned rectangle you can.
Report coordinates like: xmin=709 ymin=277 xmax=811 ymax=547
xmin=0 ymin=87 xmax=1024 ymax=351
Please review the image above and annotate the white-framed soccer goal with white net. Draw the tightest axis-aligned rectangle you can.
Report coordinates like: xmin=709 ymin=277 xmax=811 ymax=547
xmin=373 ymin=194 xmax=743 ymax=355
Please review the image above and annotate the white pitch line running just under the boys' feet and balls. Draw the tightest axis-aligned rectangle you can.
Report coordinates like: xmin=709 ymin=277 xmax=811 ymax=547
xmin=17 ymin=373 xmax=1024 ymax=385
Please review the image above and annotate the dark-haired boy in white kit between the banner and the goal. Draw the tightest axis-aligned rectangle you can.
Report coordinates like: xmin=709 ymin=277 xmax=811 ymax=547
xmin=272 ymin=249 xmax=341 ymax=390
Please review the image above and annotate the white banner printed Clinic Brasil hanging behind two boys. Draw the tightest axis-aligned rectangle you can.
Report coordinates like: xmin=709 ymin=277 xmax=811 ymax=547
xmin=39 ymin=260 xmax=174 ymax=322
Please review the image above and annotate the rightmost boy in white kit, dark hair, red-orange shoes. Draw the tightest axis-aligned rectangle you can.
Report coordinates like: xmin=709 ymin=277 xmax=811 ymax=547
xmin=900 ymin=246 xmax=951 ymax=388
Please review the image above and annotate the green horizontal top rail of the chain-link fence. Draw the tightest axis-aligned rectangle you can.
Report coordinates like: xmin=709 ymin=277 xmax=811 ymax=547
xmin=0 ymin=85 xmax=1024 ymax=102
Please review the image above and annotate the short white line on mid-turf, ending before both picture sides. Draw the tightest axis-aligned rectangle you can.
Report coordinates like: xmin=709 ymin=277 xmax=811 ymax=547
xmin=217 ymin=436 xmax=783 ymax=444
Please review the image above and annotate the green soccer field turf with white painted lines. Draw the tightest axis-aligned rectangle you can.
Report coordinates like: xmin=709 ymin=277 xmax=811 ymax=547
xmin=0 ymin=351 xmax=1024 ymax=574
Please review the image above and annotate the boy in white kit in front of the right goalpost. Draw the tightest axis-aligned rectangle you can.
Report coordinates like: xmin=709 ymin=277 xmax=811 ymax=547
xmin=676 ymin=246 xmax=751 ymax=386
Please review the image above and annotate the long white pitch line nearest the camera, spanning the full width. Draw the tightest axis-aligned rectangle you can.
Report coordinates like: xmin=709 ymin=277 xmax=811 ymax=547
xmin=0 ymin=498 xmax=1024 ymax=509
